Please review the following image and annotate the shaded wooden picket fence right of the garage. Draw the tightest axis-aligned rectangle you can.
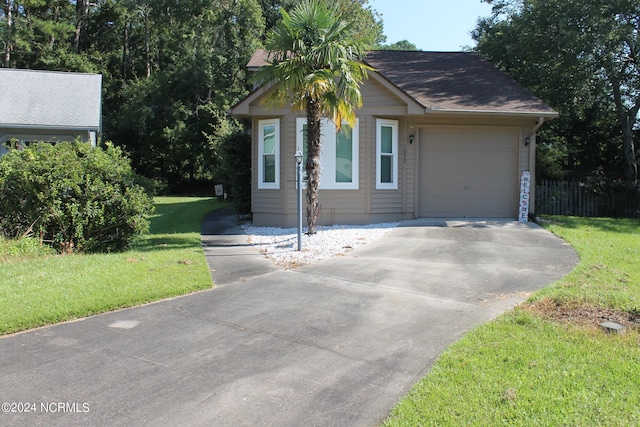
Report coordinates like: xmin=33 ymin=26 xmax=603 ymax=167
xmin=535 ymin=180 xmax=640 ymax=218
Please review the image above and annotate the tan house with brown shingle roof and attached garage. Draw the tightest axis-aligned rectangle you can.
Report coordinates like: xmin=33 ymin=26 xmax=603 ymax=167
xmin=231 ymin=50 xmax=558 ymax=227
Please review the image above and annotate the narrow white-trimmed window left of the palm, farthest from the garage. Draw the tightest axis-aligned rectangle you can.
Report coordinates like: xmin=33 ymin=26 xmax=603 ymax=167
xmin=258 ymin=119 xmax=280 ymax=190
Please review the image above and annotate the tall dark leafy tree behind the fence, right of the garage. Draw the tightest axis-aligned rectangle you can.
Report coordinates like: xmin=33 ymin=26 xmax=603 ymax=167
xmin=473 ymin=0 xmax=640 ymax=185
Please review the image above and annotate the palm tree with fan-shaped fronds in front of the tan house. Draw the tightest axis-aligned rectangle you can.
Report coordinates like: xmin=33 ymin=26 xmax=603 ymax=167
xmin=250 ymin=0 xmax=371 ymax=234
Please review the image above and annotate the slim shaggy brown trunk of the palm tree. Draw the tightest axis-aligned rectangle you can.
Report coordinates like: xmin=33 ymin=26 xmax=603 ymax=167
xmin=305 ymin=95 xmax=321 ymax=234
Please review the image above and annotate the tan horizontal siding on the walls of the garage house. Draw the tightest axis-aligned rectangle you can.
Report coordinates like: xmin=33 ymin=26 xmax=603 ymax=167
xmin=250 ymin=79 xmax=535 ymax=227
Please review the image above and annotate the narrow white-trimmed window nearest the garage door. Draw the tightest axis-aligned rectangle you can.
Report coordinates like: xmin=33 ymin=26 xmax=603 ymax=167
xmin=376 ymin=119 xmax=398 ymax=190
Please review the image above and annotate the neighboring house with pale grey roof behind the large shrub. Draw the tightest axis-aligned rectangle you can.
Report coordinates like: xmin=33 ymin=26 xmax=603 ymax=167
xmin=0 ymin=68 xmax=102 ymax=155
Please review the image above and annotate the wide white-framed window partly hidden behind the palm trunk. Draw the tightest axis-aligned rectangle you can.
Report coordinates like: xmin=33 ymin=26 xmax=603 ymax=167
xmin=296 ymin=117 xmax=359 ymax=190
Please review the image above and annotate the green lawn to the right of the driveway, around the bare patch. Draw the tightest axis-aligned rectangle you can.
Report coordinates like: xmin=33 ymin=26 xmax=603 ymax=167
xmin=385 ymin=217 xmax=640 ymax=427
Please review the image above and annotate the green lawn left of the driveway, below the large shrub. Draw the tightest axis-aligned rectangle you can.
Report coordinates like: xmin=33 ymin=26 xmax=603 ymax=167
xmin=0 ymin=197 xmax=222 ymax=334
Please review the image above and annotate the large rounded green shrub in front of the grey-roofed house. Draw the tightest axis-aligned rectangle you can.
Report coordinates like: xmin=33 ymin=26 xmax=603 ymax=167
xmin=0 ymin=142 xmax=153 ymax=252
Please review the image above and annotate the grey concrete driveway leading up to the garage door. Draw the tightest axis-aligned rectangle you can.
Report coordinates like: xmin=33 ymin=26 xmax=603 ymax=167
xmin=0 ymin=212 xmax=577 ymax=427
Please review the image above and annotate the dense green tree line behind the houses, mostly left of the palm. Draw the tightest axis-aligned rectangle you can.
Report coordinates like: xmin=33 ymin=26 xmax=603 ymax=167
xmin=0 ymin=0 xmax=412 ymax=195
